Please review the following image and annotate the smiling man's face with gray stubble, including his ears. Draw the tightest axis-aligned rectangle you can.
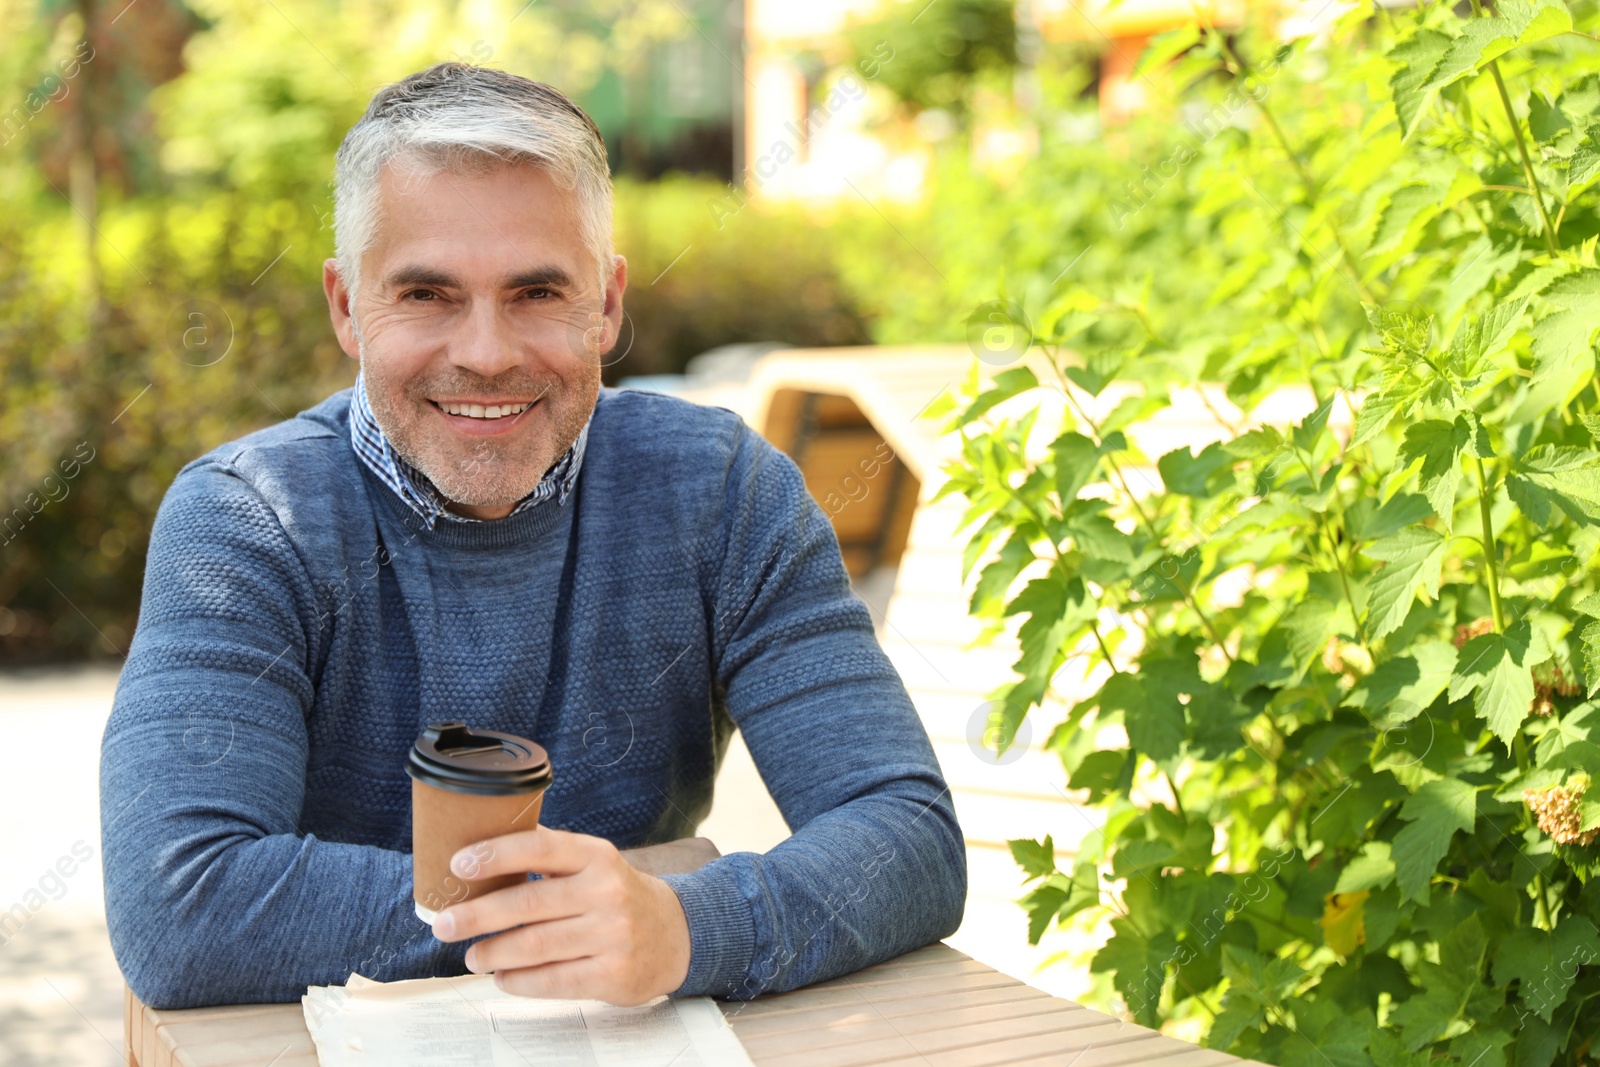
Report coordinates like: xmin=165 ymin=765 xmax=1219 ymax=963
xmin=323 ymin=165 xmax=627 ymax=518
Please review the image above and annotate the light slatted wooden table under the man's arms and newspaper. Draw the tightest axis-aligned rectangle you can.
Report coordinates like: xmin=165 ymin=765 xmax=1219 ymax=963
xmin=125 ymin=944 xmax=1261 ymax=1067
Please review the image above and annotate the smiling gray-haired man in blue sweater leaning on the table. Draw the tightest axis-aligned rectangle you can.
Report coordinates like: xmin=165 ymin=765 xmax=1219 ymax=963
xmin=101 ymin=64 xmax=966 ymax=1008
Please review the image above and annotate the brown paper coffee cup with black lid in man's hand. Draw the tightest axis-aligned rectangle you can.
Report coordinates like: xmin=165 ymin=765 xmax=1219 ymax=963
xmin=406 ymin=721 xmax=552 ymax=925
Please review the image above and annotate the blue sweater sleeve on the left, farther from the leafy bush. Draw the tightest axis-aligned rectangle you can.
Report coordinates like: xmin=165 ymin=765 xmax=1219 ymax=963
xmin=101 ymin=461 xmax=467 ymax=1008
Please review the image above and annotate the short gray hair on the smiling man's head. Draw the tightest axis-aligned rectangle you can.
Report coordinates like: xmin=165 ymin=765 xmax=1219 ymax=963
xmin=333 ymin=62 xmax=613 ymax=302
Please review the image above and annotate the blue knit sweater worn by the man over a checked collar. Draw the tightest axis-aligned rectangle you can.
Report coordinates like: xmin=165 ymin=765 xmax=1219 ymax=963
xmin=101 ymin=389 xmax=966 ymax=1008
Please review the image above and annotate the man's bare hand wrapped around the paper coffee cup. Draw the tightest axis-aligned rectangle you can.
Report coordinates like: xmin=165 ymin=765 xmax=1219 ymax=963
xmin=434 ymin=827 xmax=697 ymax=1005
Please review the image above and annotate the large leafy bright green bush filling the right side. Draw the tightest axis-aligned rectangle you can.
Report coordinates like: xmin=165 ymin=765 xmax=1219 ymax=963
xmin=944 ymin=0 xmax=1600 ymax=1067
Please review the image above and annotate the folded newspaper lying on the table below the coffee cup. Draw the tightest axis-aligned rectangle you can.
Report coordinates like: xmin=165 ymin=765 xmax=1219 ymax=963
xmin=301 ymin=974 xmax=750 ymax=1067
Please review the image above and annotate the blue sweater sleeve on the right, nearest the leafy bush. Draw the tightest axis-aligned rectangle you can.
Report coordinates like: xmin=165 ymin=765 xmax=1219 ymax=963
xmin=667 ymin=432 xmax=966 ymax=1000
